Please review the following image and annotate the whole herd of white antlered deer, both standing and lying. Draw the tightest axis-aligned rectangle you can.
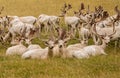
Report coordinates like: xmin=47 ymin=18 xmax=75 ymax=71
xmin=0 ymin=3 xmax=120 ymax=59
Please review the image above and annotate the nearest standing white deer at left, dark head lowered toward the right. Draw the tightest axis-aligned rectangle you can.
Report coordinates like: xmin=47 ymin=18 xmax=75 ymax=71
xmin=3 ymin=18 xmax=37 ymax=43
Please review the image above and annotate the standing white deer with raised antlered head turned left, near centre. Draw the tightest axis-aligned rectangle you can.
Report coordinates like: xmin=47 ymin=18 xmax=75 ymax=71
xmin=60 ymin=4 xmax=80 ymax=37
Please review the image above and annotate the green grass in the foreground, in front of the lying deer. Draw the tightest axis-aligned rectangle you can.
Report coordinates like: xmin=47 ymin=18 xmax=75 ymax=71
xmin=0 ymin=50 xmax=120 ymax=78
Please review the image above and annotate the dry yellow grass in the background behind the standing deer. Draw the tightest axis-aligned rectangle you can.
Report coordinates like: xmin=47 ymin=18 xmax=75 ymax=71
xmin=0 ymin=0 xmax=120 ymax=17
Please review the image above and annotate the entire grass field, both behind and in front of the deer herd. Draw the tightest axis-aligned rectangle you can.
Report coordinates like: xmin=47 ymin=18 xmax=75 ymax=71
xmin=0 ymin=0 xmax=120 ymax=78
